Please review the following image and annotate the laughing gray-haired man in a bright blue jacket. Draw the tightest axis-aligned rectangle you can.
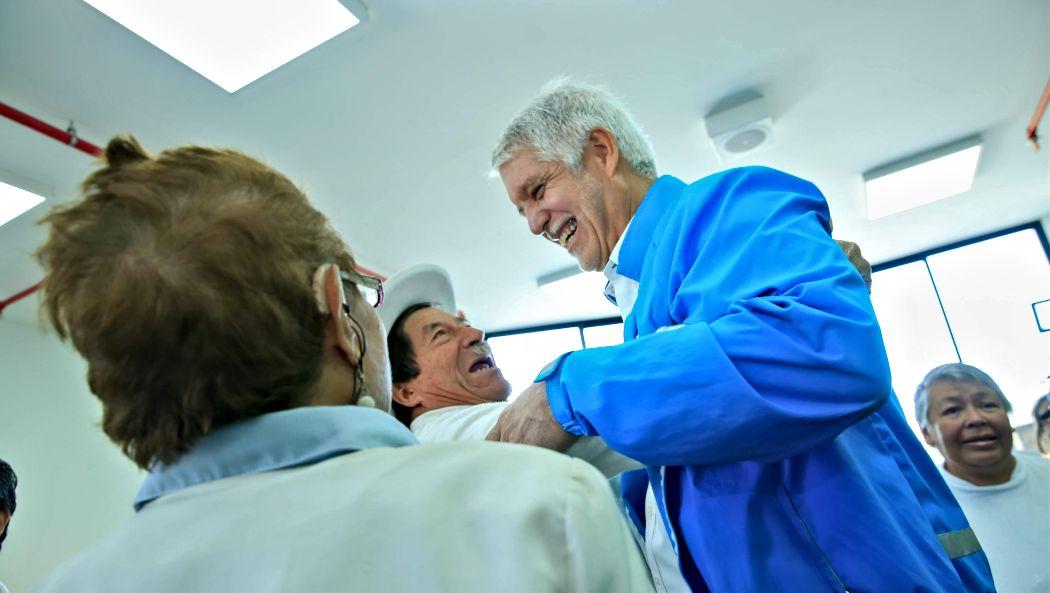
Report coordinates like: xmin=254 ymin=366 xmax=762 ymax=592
xmin=489 ymin=82 xmax=994 ymax=593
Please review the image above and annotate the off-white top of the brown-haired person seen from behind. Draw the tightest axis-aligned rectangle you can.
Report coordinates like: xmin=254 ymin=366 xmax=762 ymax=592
xmin=37 ymin=406 xmax=652 ymax=593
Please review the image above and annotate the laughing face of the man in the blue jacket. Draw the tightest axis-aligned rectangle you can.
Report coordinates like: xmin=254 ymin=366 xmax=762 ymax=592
xmin=500 ymin=147 xmax=623 ymax=271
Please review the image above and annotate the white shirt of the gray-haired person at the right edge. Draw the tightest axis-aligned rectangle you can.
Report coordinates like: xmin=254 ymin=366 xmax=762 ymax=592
xmin=941 ymin=451 xmax=1050 ymax=593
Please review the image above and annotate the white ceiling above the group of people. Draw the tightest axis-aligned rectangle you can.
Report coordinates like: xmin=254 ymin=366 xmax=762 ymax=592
xmin=0 ymin=0 xmax=1050 ymax=330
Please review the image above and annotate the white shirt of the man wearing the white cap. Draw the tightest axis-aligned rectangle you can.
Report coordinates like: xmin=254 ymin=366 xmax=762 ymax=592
xmin=412 ymin=402 xmax=645 ymax=478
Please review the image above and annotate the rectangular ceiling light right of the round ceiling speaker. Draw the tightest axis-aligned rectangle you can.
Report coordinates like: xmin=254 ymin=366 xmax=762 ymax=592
xmin=864 ymin=136 xmax=981 ymax=220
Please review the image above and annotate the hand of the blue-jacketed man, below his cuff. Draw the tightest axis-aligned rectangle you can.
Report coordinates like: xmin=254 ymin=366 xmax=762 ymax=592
xmin=486 ymin=382 xmax=580 ymax=451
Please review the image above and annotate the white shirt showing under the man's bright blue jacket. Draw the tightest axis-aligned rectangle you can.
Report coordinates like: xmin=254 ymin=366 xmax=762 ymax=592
xmin=603 ymin=218 xmax=689 ymax=593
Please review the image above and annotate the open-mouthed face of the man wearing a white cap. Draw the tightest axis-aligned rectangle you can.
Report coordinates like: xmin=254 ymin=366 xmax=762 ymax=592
xmin=394 ymin=306 xmax=510 ymax=411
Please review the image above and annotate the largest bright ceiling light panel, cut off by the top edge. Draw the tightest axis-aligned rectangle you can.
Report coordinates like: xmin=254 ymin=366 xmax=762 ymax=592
xmin=84 ymin=0 xmax=360 ymax=92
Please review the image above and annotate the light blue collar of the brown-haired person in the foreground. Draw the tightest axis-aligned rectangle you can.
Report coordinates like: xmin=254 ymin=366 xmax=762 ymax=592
xmin=134 ymin=405 xmax=419 ymax=511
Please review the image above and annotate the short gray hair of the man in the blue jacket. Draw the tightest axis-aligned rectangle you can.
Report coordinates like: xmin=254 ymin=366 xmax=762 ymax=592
xmin=491 ymin=79 xmax=656 ymax=178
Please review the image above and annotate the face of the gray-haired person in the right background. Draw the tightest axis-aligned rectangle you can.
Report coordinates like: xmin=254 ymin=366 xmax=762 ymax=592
xmin=923 ymin=380 xmax=1013 ymax=473
